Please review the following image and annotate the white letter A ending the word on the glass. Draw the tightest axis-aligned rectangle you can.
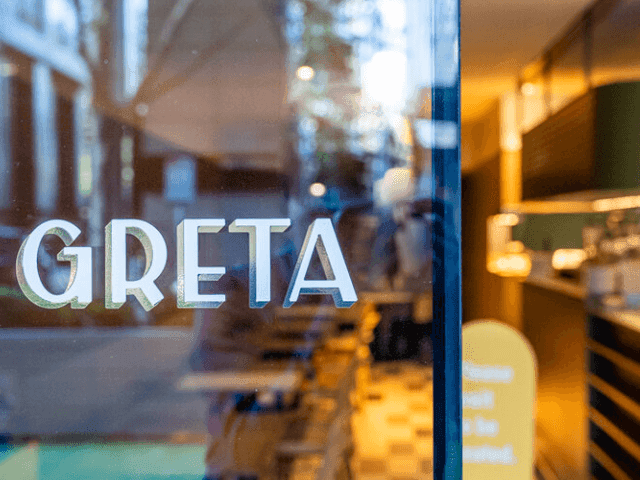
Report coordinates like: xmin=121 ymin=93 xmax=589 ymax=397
xmin=283 ymin=218 xmax=358 ymax=308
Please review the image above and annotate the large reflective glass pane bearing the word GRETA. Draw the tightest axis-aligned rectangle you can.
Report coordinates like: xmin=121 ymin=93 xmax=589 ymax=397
xmin=0 ymin=0 xmax=461 ymax=479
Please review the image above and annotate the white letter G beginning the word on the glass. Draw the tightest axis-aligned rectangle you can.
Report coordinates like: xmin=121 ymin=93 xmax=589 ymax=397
xmin=16 ymin=220 xmax=93 ymax=308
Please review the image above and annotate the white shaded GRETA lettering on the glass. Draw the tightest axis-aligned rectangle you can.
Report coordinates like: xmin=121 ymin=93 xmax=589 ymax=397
xmin=16 ymin=218 xmax=358 ymax=311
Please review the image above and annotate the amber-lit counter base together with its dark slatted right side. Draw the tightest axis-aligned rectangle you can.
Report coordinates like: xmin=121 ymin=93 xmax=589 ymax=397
xmin=523 ymin=252 xmax=640 ymax=480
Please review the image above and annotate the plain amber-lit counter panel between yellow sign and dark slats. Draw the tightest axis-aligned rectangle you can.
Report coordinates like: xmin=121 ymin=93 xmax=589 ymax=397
xmin=522 ymin=275 xmax=589 ymax=480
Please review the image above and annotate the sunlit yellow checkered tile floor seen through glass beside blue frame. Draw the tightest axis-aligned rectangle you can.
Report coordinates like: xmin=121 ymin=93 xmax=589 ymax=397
xmin=352 ymin=363 xmax=433 ymax=480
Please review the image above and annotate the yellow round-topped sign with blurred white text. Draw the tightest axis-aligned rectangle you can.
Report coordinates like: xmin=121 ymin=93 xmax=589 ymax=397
xmin=462 ymin=320 xmax=536 ymax=480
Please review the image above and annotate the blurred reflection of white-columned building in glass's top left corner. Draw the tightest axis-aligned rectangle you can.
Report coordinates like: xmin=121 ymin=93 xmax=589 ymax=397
xmin=0 ymin=0 xmax=95 ymax=280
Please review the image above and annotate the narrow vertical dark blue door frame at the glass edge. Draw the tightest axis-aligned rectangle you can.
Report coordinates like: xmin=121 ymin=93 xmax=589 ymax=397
xmin=432 ymin=0 xmax=462 ymax=480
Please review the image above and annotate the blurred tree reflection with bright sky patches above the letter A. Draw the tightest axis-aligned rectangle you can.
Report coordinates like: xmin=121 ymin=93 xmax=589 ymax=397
xmin=285 ymin=0 xmax=383 ymax=202
